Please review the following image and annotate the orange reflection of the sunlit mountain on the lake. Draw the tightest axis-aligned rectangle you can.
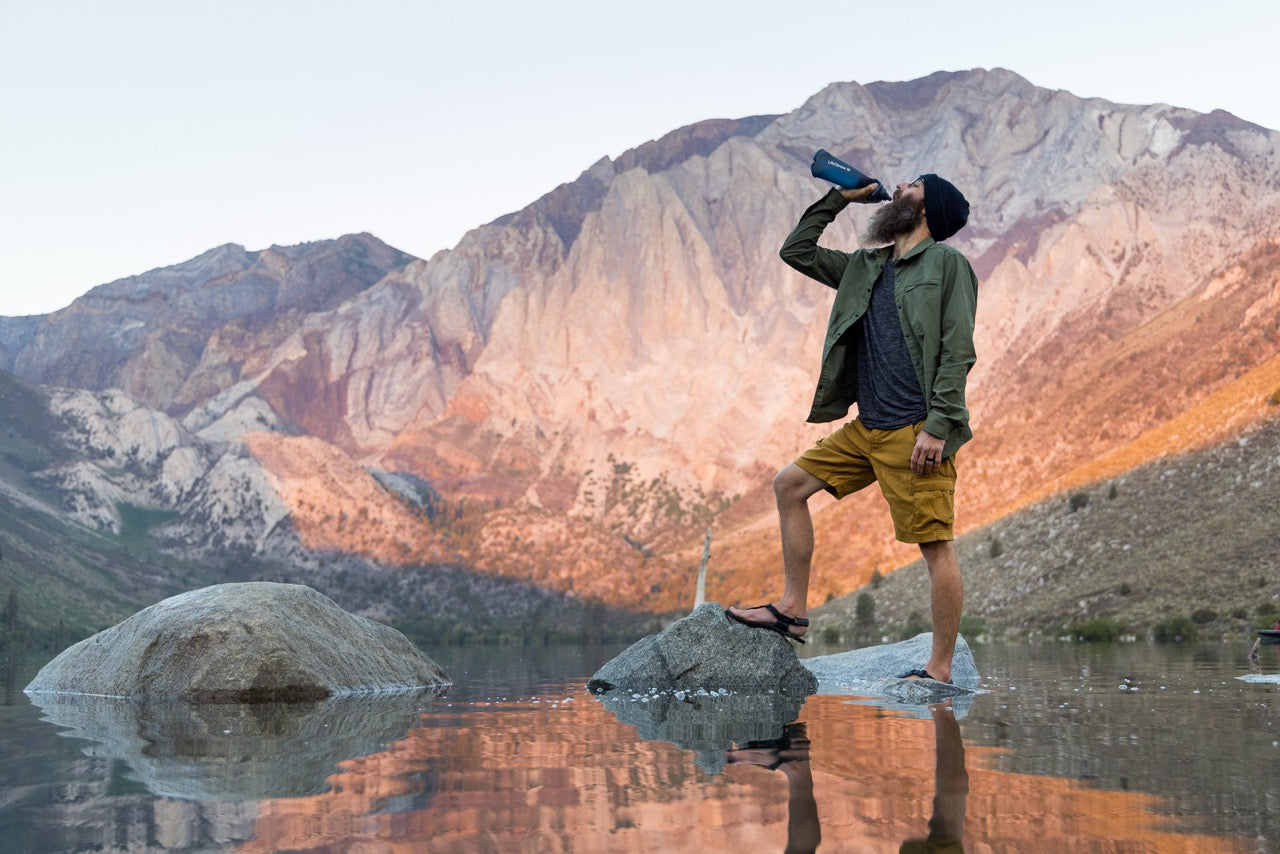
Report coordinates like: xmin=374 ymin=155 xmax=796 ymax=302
xmin=242 ymin=697 xmax=1233 ymax=853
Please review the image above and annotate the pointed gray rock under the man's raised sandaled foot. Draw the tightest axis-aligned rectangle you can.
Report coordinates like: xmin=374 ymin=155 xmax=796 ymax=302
xmin=586 ymin=602 xmax=818 ymax=696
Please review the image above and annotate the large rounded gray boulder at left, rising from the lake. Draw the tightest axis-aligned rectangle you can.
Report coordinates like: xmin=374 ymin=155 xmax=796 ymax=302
xmin=26 ymin=581 xmax=449 ymax=703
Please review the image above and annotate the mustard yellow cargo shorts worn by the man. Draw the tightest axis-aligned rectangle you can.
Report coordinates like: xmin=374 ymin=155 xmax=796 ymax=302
xmin=796 ymin=420 xmax=956 ymax=543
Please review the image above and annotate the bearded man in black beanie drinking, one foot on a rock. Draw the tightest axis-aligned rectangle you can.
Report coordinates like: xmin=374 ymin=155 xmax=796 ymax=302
xmin=726 ymin=174 xmax=978 ymax=682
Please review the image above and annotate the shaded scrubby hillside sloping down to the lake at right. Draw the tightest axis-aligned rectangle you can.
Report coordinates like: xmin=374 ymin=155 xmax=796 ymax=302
xmin=813 ymin=411 xmax=1280 ymax=638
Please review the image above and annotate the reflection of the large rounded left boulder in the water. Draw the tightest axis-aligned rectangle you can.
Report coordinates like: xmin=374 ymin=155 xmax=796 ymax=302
xmin=31 ymin=691 xmax=445 ymax=802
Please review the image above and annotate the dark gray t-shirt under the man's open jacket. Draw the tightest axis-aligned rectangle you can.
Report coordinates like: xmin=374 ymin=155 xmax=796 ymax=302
xmin=854 ymin=261 xmax=928 ymax=430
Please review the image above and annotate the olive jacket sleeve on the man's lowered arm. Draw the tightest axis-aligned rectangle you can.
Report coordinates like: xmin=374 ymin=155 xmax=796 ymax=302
xmin=924 ymin=252 xmax=978 ymax=445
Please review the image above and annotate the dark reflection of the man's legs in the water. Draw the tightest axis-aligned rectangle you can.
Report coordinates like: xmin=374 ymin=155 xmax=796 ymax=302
xmin=726 ymin=703 xmax=969 ymax=854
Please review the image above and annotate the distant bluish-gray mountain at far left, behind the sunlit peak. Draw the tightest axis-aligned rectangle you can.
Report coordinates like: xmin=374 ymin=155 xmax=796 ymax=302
xmin=0 ymin=234 xmax=411 ymax=412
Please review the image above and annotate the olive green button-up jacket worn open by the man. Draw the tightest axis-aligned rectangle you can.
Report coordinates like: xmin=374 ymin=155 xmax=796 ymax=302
xmin=781 ymin=189 xmax=978 ymax=457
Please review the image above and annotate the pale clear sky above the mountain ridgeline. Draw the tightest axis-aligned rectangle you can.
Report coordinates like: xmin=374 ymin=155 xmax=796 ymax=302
xmin=0 ymin=0 xmax=1280 ymax=315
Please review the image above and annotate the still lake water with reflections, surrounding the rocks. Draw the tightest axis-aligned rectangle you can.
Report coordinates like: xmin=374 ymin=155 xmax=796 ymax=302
xmin=0 ymin=643 xmax=1280 ymax=854
